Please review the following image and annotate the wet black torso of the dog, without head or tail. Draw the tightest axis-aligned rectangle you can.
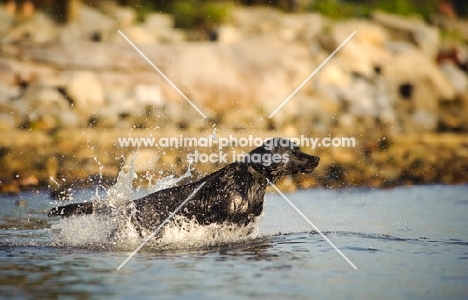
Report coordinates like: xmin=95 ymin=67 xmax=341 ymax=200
xmin=134 ymin=163 xmax=266 ymax=233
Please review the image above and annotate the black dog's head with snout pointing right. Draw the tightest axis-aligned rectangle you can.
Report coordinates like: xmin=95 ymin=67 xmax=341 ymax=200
xmin=243 ymin=138 xmax=320 ymax=182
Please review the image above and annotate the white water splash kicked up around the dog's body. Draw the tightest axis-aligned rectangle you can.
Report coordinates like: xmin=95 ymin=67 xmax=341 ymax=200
xmin=51 ymin=156 xmax=261 ymax=251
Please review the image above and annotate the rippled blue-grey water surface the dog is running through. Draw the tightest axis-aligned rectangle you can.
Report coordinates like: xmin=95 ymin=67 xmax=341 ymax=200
xmin=0 ymin=185 xmax=468 ymax=299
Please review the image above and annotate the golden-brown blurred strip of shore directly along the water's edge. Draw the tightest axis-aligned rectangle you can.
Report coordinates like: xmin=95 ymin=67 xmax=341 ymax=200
xmin=0 ymin=129 xmax=468 ymax=193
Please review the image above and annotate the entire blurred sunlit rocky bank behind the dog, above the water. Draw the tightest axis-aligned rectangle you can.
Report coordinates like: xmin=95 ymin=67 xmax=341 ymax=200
xmin=0 ymin=0 xmax=468 ymax=194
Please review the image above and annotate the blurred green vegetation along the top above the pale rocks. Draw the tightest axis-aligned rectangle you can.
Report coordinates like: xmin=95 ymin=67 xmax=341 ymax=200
xmin=0 ymin=0 xmax=468 ymax=28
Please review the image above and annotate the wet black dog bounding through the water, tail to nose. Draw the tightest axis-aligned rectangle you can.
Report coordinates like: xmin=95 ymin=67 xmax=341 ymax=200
xmin=48 ymin=138 xmax=319 ymax=234
